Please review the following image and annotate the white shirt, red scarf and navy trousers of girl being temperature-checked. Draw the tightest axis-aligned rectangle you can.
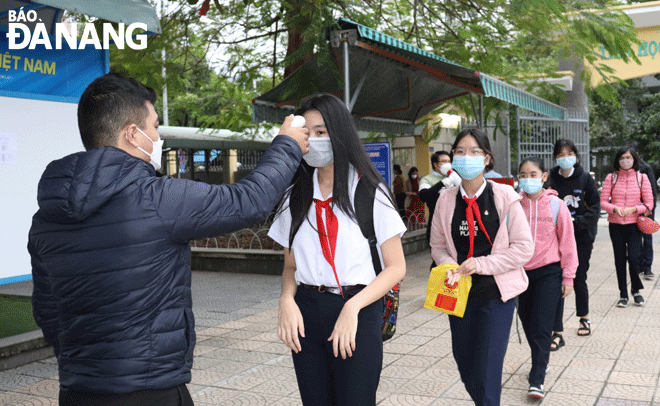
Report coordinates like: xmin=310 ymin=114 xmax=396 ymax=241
xmin=268 ymin=168 xmax=406 ymax=406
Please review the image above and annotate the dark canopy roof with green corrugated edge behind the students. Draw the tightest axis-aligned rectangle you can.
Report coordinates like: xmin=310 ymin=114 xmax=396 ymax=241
xmin=252 ymin=19 xmax=565 ymax=133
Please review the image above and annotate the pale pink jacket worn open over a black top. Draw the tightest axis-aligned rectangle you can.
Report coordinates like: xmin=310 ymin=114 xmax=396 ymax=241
xmin=431 ymin=181 xmax=534 ymax=302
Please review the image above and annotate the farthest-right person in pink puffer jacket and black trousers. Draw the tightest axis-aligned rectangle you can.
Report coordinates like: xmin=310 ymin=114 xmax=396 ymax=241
xmin=600 ymin=147 xmax=653 ymax=307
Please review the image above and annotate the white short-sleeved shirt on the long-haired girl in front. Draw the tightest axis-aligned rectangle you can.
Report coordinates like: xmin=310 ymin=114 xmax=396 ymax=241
xmin=268 ymin=168 xmax=406 ymax=287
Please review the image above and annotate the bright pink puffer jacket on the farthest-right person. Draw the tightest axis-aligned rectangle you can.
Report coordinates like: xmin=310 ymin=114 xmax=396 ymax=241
xmin=600 ymin=169 xmax=653 ymax=224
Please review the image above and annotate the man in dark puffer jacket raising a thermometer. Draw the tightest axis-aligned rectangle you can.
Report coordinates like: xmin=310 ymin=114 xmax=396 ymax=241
xmin=28 ymin=74 xmax=309 ymax=406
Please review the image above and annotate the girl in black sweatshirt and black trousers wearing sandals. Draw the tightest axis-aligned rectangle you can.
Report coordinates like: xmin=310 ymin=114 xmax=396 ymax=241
xmin=548 ymin=139 xmax=600 ymax=351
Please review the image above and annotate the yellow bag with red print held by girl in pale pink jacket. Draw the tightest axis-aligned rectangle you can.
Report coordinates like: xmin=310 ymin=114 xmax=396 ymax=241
xmin=424 ymin=264 xmax=472 ymax=317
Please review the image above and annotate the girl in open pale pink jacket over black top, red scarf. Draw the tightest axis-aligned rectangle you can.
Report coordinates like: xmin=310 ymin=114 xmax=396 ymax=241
xmin=431 ymin=129 xmax=534 ymax=406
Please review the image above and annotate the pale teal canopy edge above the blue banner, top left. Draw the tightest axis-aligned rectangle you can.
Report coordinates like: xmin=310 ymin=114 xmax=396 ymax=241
xmin=0 ymin=0 xmax=161 ymax=34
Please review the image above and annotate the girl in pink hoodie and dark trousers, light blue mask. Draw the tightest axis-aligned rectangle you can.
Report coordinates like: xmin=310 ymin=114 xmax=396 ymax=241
xmin=518 ymin=156 xmax=578 ymax=399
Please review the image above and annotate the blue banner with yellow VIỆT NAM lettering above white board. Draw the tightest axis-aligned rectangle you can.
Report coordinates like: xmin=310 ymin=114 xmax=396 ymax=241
xmin=0 ymin=31 xmax=109 ymax=103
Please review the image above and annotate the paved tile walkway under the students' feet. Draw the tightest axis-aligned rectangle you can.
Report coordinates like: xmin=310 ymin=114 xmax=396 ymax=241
xmin=0 ymin=220 xmax=660 ymax=406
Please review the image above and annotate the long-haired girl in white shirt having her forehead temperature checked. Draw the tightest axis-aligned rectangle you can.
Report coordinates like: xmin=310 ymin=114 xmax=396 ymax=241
xmin=268 ymin=94 xmax=406 ymax=406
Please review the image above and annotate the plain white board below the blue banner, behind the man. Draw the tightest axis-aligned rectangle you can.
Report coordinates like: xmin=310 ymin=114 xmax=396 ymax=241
xmin=0 ymin=97 xmax=84 ymax=284
